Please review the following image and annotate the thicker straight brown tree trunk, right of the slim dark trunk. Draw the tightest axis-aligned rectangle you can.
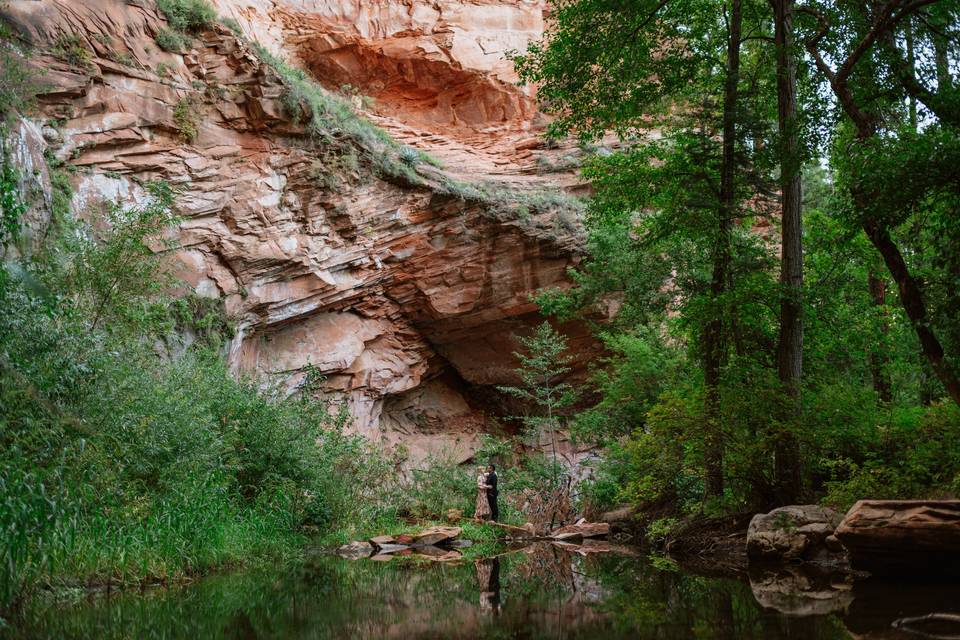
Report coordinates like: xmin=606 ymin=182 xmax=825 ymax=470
xmin=770 ymin=0 xmax=803 ymax=503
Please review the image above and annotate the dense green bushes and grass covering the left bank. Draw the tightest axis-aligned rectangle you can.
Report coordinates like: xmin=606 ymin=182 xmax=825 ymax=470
xmin=0 ymin=179 xmax=391 ymax=609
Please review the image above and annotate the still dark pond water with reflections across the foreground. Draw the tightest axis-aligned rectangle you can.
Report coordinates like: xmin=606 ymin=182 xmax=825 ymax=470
xmin=0 ymin=544 xmax=960 ymax=640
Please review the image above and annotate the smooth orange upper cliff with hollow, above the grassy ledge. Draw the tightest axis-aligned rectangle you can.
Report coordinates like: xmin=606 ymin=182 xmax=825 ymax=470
xmin=215 ymin=0 xmax=592 ymax=185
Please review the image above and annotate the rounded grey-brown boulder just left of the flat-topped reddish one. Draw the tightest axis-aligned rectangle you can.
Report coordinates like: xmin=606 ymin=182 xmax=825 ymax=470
xmin=747 ymin=504 xmax=840 ymax=560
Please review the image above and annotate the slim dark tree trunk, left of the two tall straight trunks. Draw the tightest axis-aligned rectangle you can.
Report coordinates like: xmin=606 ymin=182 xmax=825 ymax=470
xmin=703 ymin=0 xmax=743 ymax=498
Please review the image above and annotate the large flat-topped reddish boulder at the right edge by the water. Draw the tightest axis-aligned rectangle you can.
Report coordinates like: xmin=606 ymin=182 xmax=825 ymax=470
xmin=836 ymin=500 xmax=960 ymax=578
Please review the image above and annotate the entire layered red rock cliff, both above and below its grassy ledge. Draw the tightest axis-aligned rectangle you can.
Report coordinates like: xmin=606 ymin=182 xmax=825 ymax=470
xmin=3 ymin=0 xmax=597 ymax=467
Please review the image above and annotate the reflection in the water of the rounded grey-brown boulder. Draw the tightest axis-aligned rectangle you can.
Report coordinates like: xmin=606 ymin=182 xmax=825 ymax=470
xmin=750 ymin=566 xmax=853 ymax=616
